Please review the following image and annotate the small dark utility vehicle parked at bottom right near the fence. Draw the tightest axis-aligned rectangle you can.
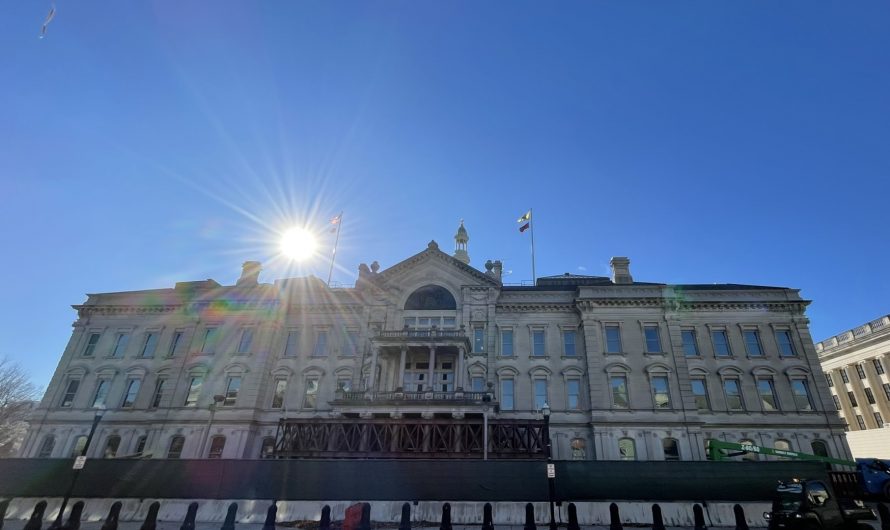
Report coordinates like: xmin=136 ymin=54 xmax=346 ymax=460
xmin=763 ymin=472 xmax=877 ymax=530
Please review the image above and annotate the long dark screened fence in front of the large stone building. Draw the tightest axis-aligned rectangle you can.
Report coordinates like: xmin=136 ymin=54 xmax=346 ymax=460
xmin=0 ymin=458 xmax=828 ymax=502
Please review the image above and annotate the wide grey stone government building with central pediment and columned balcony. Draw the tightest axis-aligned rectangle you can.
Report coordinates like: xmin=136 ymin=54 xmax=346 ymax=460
xmin=22 ymin=226 xmax=849 ymax=460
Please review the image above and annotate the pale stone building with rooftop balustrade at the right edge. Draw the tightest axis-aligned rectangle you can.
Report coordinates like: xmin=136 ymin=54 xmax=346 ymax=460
xmin=816 ymin=315 xmax=890 ymax=459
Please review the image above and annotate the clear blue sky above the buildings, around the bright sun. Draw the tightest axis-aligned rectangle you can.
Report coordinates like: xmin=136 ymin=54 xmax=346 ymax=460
xmin=0 ymin=0 xmax=890 ymax=385
